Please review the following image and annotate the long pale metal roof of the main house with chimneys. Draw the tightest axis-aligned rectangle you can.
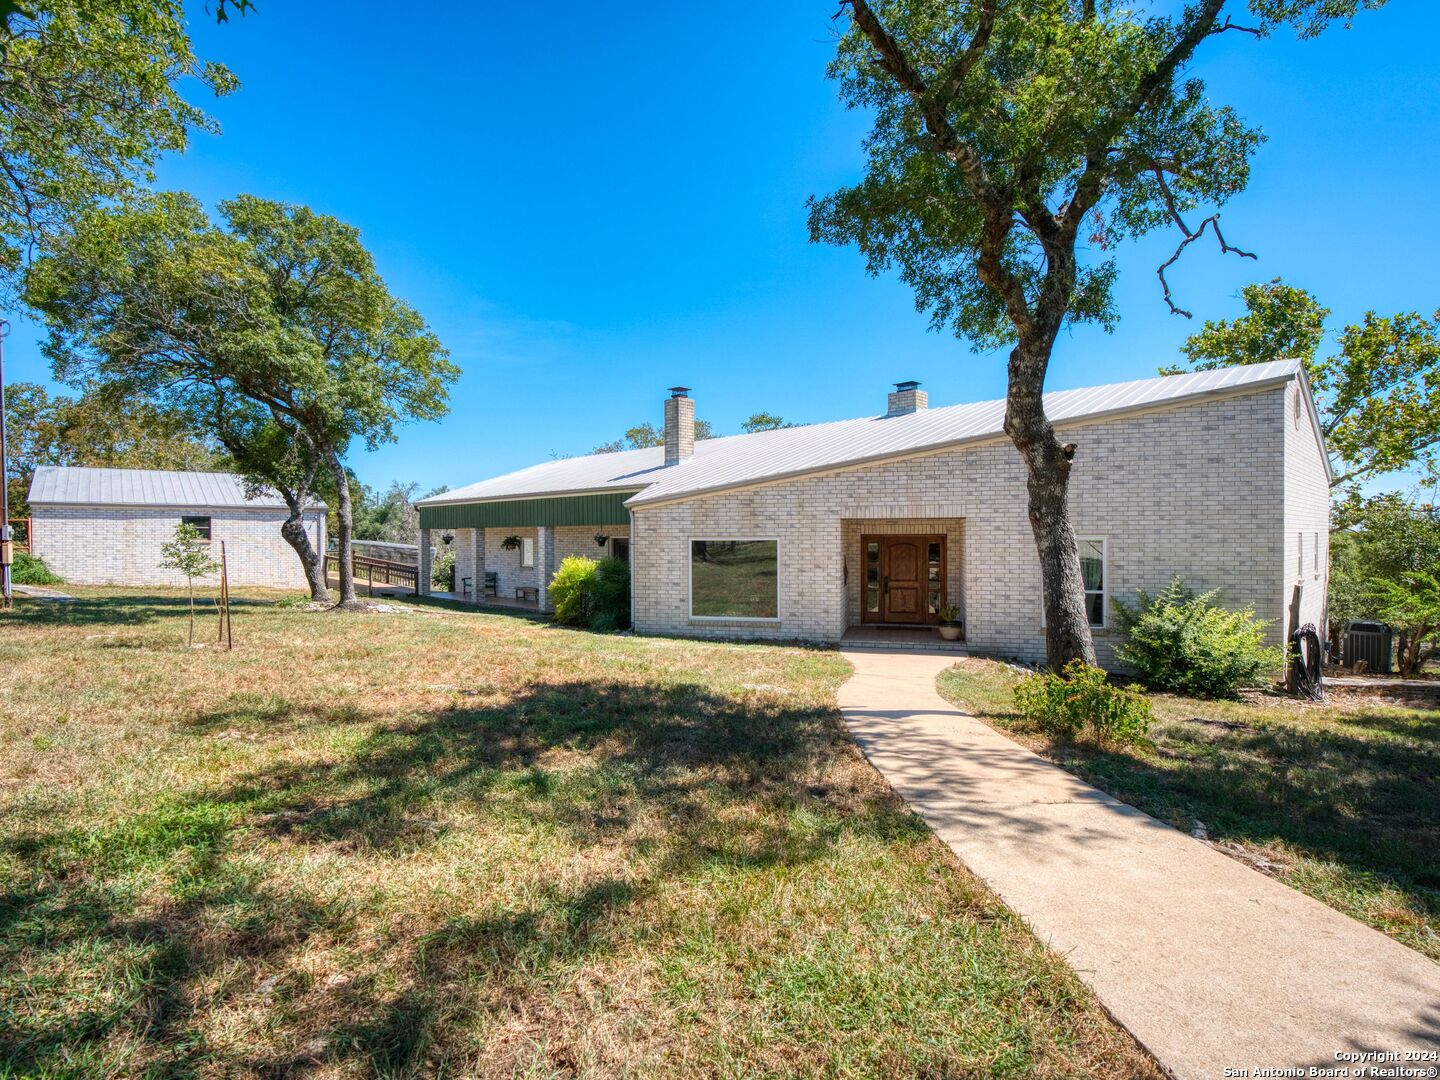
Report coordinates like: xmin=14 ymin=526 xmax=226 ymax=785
xmin=418 ymin=360 xmax=1300 ymax=507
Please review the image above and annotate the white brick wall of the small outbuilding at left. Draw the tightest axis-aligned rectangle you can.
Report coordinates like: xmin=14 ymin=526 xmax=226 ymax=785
xmin=30 ymin=505 xmax=324 ymax=589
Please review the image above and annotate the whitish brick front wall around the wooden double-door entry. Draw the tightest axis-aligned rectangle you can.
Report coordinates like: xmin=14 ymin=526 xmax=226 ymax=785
xmin=631 ymin=387 xmax=1296 ymax=662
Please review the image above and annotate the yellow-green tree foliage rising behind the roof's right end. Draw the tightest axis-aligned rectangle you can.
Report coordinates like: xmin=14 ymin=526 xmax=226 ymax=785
xmin=1184 ymin=278 xmax=1440 ymax=484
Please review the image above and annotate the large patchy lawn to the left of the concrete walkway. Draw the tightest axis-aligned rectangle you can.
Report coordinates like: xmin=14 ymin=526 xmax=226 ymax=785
xmin=0 ymin=589 xmax=1158 ymax=1077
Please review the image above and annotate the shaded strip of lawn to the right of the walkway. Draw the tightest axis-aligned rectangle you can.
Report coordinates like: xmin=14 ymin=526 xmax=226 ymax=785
xmin=939 ymin=660 xmax=1440 ymax=960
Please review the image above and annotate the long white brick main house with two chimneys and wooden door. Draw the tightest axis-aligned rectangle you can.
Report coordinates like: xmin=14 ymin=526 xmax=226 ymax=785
xmin=419 ymin=361 xmax=1329 ymax=662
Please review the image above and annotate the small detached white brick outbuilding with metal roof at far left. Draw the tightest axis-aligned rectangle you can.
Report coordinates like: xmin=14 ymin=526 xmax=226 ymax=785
xmin=30 ymin=465 xmax=325 ymax=589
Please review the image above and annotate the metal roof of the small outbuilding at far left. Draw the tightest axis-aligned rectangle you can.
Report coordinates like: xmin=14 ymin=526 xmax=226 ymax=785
xmin=30 ymin=465 xmax=325 ymax=510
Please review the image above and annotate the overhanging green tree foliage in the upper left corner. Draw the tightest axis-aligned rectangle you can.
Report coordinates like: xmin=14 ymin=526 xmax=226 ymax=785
xmin=0 ymin=0 xmax=238 ymax=301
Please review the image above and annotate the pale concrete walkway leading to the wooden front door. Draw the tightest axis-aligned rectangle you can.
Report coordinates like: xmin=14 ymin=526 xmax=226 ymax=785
xmin=840 ymin=649 xmax=1440 ymax=1080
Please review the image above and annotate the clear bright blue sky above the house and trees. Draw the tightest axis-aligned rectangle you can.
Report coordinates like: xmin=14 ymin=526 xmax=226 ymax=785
xmin=7 ymin=0 xmax=1440 ymax=488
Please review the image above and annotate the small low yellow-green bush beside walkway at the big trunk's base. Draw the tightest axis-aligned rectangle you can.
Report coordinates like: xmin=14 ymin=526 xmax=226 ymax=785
xmin=1015 ymin=660 xmax=1153 ymax=743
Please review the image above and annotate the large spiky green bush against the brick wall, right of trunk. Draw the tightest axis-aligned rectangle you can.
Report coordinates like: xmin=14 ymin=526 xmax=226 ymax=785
xmin=1115 ymin=577 xmax=1284 ymax=697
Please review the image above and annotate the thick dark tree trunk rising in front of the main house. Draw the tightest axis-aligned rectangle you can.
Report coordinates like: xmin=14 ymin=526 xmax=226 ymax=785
xmin=1005 ymin=333 xmax=1096 ymax=671
